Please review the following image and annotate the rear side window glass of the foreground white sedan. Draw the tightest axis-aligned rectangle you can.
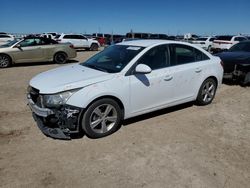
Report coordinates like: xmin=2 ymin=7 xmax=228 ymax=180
xmin=170 ymin=44 xmax=209 ymax=65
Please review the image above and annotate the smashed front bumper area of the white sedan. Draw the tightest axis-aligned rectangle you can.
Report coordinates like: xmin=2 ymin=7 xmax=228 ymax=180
xmin=27 ymin=94 xmax=83 ymax=140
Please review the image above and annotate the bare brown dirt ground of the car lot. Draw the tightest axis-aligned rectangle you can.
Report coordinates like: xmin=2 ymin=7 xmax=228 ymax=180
xmin=0 ymin=51 xmax=250 ymax=188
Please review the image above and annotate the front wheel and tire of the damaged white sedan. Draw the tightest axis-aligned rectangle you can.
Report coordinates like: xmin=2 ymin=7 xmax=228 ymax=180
xmin=81 ymin=98 xmax=122 ymax=138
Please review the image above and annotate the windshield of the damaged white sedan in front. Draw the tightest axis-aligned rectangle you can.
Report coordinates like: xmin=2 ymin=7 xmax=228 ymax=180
xmin=81 ymin=45 xmax=144 ymax=73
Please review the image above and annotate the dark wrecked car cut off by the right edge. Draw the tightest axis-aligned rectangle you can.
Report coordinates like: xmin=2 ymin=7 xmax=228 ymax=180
xmin=215 ymin=41 xmax=250 ymax=84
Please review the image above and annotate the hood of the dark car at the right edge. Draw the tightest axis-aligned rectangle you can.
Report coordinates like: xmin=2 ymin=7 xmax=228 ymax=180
xmin=215 ymin=51 xmax=250 ymax=63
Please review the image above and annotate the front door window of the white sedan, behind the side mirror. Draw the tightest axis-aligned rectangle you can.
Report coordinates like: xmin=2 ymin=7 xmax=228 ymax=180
xmin=138 ymin=45 xmax=168 ymax=70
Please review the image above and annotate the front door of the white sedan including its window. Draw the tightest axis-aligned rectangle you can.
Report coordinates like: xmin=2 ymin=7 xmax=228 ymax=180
xmin=129 ymin=45 xmax=173 ymax=116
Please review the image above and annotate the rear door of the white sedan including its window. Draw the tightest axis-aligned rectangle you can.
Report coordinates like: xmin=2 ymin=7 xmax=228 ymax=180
xmin=169 ymin=44 xmax=209 ymax=102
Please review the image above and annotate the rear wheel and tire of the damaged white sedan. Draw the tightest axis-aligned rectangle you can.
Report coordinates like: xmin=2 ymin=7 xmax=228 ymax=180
xmin=196 ymin=78 xmax=217 ymax=106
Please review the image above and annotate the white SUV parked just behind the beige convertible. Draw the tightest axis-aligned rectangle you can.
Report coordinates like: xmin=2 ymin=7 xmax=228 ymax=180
xmin=55 ymin=34 xmax=100 ymax=51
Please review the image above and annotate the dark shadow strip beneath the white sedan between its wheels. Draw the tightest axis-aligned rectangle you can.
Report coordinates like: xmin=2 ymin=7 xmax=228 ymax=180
xmin=122 ymin=102 xmax=194 ymax=126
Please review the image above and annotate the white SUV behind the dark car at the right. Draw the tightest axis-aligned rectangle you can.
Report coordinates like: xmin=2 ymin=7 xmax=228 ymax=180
xmin=211 ymin=35 xmax=248 ymax=53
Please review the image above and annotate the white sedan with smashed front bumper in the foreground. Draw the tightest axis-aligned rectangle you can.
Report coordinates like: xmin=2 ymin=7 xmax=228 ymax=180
xmin=27 ymin=40 xmax=223 ymax=139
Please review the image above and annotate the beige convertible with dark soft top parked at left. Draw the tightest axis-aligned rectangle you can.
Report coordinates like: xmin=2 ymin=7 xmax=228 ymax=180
xmin=0 ymin=37 xmax=76 ymax=68
